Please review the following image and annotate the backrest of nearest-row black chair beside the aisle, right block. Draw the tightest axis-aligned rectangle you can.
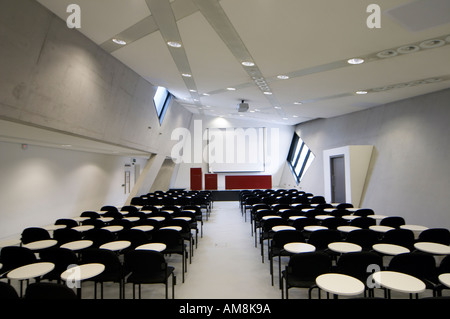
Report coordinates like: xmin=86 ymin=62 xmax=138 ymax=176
xmin=287 ymin=251 xmax=332 ymax=281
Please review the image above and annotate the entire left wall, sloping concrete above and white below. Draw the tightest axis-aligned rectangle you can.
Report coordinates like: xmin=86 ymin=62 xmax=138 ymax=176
xmin=0 ymin=0 xmax=192 ymax=239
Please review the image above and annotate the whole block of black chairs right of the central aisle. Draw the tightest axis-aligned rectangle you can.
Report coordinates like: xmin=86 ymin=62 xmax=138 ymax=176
xmin=240 ymin=190 xmax=450 ymax=298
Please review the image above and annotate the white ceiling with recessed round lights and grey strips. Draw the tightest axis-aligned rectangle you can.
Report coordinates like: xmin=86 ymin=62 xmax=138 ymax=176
xmin=37 ymin=0 xmax=450 ymax=125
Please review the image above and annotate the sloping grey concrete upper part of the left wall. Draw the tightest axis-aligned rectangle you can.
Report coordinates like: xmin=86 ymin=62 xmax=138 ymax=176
xmin=0 ymin=0 xmax=192 ymax=154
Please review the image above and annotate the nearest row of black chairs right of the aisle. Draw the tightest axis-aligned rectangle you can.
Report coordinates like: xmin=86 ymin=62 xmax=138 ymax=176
xmin=280 ymin=250 xmax=450 ymax=298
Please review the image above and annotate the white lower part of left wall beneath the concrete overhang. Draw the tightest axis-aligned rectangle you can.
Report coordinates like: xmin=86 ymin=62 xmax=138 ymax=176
xmin=0 ymin=142 xmax=147 ymax=239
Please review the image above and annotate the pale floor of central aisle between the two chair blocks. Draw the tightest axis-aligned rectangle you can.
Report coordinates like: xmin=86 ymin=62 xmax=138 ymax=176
xmin=175 ymin=202 xmax=281 ymax=299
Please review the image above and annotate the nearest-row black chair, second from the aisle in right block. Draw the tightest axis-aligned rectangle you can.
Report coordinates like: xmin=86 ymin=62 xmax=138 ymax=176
xmin=335 ymin=251 xmax=383 ymax=297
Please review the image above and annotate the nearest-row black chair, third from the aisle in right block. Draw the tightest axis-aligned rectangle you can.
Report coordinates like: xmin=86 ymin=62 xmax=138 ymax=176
xmin=387 ymin=252 xmax=439 ymax=296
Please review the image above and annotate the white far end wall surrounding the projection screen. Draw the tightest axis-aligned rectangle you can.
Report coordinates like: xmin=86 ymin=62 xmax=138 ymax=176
xmin=171 ymin=115 xmax=294 ymax=189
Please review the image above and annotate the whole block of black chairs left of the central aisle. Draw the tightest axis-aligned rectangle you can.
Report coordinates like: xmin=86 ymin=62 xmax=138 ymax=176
xmin=0 ymin=199 xmax=214 ymax=298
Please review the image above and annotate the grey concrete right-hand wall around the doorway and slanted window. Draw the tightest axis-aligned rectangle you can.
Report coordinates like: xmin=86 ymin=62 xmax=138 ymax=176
xmin=282 ymin=90 xmax=450 ymax=228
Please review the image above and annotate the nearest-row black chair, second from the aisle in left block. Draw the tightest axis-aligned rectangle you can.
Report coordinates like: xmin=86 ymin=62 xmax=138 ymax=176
xmin=81 ymin=248 xmax=126 ymax=299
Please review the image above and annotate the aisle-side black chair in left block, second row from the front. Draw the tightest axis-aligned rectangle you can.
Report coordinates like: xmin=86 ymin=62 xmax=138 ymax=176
xmin=152 ymin=229 xmax=188 ymax=283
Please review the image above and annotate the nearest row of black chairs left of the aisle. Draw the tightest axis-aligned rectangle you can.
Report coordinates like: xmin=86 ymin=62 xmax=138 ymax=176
xmin=0 ymin=246 xmax=176 ymax=300
